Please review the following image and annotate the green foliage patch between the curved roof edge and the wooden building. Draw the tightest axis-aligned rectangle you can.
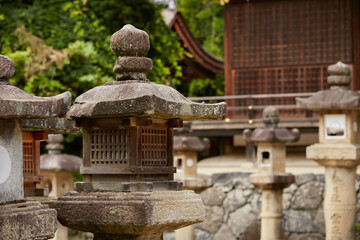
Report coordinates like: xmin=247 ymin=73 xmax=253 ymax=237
xmin=177 ymin=0 xmax=224 ymax=58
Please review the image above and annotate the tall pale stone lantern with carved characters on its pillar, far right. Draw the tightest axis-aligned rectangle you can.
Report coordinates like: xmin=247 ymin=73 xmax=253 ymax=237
xmin=296 ymin=62 xmax=360 ymax=239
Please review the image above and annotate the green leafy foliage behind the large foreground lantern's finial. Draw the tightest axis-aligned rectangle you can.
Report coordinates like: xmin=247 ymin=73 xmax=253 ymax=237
xmin=0 ymin=0 xmax=184 ymax=98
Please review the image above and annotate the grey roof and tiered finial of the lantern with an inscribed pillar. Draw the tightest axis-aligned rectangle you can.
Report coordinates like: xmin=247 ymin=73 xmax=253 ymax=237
xmin=296 ymin=62 xmax=360 ymax=111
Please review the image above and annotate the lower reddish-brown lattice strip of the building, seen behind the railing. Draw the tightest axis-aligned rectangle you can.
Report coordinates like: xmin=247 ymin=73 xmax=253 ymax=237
xmin=233 ymin=65 xmax=328 ymax=117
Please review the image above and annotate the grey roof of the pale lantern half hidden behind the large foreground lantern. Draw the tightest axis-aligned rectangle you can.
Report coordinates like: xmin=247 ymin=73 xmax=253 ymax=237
xmin=173 ymin=122 xmax=210 ymax=152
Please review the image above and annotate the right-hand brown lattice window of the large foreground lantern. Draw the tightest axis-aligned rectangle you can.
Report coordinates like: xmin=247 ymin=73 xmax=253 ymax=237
xmin=140 ymin=127 xmax=168 ymax=166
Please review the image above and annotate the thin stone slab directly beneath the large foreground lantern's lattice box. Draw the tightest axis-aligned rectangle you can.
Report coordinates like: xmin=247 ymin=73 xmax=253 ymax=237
xmin=74 ymin=181 xmax=183 ymax=192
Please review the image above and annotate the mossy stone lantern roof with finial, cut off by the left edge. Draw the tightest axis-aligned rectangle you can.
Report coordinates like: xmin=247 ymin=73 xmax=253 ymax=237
xmin=0 ymin=55 xmax=71 ymax=119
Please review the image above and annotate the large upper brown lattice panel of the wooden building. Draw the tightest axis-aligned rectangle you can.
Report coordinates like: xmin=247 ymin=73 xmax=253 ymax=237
xmin=229 ymin=0 xmax=353 ymax=69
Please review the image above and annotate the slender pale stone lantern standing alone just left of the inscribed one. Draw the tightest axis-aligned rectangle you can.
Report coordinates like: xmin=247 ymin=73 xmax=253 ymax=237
xmin=243 ymin=106 xmax=300 ymax=240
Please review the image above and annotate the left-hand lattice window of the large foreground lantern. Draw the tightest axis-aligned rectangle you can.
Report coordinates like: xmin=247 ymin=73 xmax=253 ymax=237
xmin=90 ymin=128 xmax=129 ymax=165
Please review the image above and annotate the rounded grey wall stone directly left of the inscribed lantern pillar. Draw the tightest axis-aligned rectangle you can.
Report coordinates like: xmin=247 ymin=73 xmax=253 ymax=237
xmin=291 ymin=181 xmax=324 ymax=209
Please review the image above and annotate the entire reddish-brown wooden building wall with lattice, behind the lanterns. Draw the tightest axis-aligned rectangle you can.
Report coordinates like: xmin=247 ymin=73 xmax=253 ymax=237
xmin=225 ymin=0 xmax=360 ymax=117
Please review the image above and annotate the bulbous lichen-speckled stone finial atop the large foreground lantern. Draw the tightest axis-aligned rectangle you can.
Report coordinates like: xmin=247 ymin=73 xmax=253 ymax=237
xmin=110 ymin=24 xmax=152 ymax=81
